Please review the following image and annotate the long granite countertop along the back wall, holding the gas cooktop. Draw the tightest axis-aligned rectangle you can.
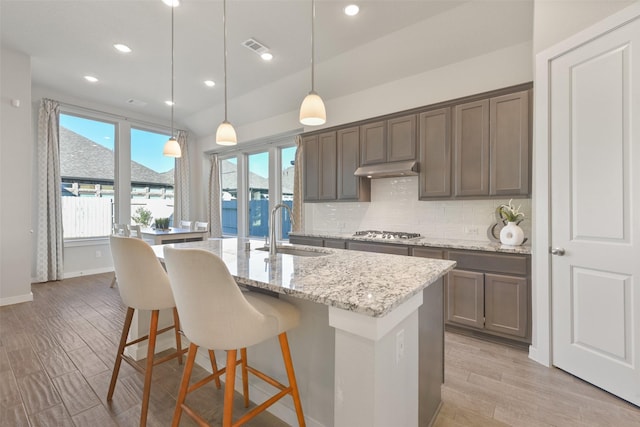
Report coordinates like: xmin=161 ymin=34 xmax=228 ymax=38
xmin=289 ymin=232 xmax=531 ymax=255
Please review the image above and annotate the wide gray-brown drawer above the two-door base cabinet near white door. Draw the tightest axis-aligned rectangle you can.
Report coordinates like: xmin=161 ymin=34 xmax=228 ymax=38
xmin=449 ymin=251 xmax=529 ymax=276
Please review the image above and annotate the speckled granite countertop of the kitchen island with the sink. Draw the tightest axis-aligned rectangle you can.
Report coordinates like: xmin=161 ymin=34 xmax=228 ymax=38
xmin=152 ymin=239 xmax=455 ymax=317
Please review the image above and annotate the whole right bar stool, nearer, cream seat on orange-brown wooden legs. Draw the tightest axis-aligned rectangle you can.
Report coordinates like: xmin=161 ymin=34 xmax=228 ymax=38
xmin=164 ymin=247 xmax=305 ymax=427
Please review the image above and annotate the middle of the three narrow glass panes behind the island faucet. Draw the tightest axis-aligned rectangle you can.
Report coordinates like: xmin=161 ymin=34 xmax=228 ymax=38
xmin=248 ymin=152 xmax=269 ymax=237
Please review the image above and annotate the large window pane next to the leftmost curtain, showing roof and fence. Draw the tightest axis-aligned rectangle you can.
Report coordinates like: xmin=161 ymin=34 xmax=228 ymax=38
xmin=60 ymin=114 xmax=116 ymax=239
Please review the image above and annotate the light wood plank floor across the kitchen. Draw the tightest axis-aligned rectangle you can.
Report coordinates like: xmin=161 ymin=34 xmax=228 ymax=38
xmin=0 ymin=274 xmax=640 ymax=427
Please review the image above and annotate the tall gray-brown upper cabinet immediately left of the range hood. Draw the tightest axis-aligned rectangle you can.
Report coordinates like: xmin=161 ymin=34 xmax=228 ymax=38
xmin=336 ymin=126 xmax=371 ymax=201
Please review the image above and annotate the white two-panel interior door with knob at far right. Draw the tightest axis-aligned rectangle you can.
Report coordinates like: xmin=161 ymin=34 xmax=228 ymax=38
xmin=549 ymin=14 xmax=640 ymax=405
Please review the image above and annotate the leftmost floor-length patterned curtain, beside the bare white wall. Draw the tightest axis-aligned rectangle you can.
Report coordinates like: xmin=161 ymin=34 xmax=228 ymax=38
xmin=35 ymin=99 xmax=64 ymax=282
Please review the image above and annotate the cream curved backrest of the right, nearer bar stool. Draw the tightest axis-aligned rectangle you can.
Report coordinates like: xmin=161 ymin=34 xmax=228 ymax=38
xmin=164 ymin=247 xmax=268 ymax=350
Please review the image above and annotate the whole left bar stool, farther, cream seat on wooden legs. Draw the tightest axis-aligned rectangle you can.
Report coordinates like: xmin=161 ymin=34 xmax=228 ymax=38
xmin=107 ymin=235 xmax=208 ymax=426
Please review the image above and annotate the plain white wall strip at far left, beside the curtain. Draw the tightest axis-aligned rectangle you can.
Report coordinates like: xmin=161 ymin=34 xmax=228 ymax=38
xmin=0 ymin=47 xmax=33 ymax=305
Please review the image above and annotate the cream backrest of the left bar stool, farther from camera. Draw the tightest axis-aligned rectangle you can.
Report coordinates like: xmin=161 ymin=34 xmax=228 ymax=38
xmin=109 ymin=236 xmax=175 ymax=310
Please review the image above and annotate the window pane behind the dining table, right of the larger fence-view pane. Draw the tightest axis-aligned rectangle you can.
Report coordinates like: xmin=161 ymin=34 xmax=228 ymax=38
xmin=129 ymin=128 xmax=176 ymax=227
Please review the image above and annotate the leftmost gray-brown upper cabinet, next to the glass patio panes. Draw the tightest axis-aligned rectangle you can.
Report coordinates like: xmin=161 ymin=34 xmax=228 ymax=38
xmin=302 ymin=132 xmax=337 ymax=202
